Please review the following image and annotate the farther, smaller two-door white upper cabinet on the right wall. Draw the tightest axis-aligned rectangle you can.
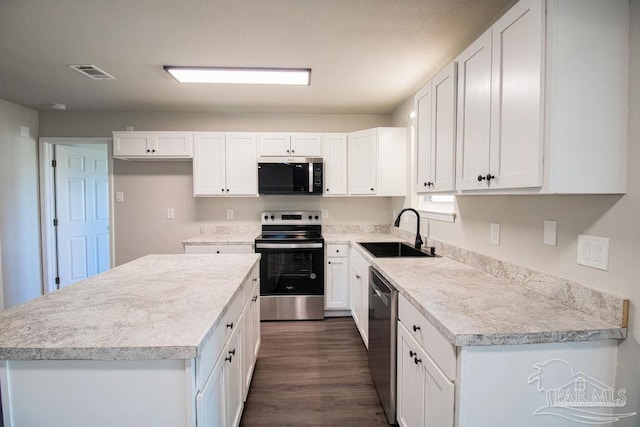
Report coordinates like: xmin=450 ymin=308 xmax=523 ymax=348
xmin=415 ymin=62 xmax=456 ymax=193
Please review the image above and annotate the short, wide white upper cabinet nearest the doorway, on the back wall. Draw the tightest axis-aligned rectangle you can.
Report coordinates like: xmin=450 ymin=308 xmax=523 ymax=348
xmin=113 ymin=132 xmax=193 ymax=160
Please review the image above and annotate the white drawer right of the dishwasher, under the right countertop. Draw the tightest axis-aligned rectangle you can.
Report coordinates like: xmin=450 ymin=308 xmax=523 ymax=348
xmin=398 ymin=295 xmax=456 ymax=380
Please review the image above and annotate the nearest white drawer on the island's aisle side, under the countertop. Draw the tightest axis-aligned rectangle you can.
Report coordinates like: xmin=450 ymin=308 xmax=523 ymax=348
xmin=196 ymin=293 xmax=242 ymax=390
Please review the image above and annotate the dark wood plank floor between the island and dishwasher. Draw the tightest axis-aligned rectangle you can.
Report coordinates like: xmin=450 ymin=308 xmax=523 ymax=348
xmin=240 ymin=318 xmax=388 ymax=427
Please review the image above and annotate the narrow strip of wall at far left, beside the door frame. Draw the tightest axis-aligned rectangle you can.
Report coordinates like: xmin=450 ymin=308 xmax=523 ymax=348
xmin=0 ymin=100 xmax=42 ymax=308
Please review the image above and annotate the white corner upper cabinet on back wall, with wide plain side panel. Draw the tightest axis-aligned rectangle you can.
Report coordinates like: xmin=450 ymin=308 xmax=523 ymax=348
xmin=347 ymin=128 xmax=407 ymax=196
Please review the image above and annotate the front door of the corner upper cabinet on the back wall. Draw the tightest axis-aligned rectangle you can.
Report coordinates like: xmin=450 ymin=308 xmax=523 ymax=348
xmin=347 ymin=129 xmax=378 ymax=196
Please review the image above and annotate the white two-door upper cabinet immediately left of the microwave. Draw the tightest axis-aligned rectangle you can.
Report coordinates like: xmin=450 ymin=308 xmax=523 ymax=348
xmin=193 ymin=132 xmax=258 ymax=196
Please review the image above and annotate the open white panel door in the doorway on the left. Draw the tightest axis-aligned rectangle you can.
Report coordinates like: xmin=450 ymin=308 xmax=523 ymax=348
xmin=55 ymin=145 xmax=110 ymax=287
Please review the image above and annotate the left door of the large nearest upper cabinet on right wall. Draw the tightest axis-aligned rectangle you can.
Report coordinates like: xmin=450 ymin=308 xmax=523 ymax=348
xmin=456 ymin=30 xmax=491 ymax=190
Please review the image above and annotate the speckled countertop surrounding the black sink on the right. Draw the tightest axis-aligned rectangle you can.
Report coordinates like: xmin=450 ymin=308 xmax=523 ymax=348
xmin=336 ymin=234 xmax=626 ymax=346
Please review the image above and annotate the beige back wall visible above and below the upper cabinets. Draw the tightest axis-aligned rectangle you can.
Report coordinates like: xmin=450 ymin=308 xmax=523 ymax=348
xmin=40 ymin=111 xmax=391 ymax=265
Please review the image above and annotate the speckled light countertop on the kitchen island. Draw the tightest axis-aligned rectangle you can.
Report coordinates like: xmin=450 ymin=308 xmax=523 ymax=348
xmin=0 ymin=254 xmax=260 ymax=360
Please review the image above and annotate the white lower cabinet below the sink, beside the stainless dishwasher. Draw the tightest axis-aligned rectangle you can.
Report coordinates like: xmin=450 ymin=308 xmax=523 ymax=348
xmin=349 ymin=248 xmax=369 ymax=348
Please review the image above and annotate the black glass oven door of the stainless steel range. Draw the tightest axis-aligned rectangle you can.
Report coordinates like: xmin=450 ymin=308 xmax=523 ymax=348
xmin=256 ymin=242 xmax=324 ymax=296
